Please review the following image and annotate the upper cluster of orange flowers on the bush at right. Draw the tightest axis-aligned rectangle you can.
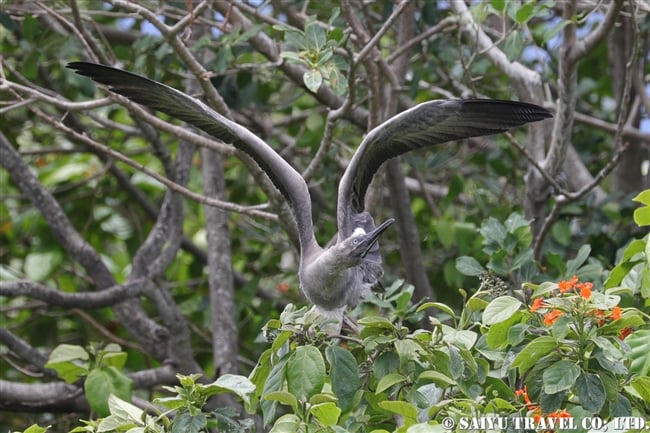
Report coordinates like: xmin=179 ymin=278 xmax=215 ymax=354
xmin=530 ymin=275 xmax=632 ymax=339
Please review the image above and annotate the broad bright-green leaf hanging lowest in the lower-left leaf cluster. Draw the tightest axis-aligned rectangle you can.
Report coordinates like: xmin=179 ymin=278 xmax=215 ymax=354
xmin=84 ymin=367 xmax=133 ymax=416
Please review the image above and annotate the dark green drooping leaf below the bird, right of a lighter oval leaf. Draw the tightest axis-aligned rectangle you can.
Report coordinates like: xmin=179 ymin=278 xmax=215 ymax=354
xmin=325 ymin=346 xmax=361 ymax=412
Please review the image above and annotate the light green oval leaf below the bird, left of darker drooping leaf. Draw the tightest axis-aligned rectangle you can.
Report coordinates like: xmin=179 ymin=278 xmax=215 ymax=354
xmin=287 ymin=346 xmax=325 ymax=400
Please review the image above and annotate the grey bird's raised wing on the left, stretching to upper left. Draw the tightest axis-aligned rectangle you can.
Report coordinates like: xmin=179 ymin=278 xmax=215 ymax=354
xmin=67 ymin=62 xmax=313 ymax=246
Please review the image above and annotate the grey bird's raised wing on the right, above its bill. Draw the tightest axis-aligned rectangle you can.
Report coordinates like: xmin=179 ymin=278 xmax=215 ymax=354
xmin=338 ymin=99 xmax=551 ymax=236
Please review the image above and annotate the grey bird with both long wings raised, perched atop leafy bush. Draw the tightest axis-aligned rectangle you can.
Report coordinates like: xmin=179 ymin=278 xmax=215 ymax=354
xmin=67 ymin=62 xmax=551 ymax=320
